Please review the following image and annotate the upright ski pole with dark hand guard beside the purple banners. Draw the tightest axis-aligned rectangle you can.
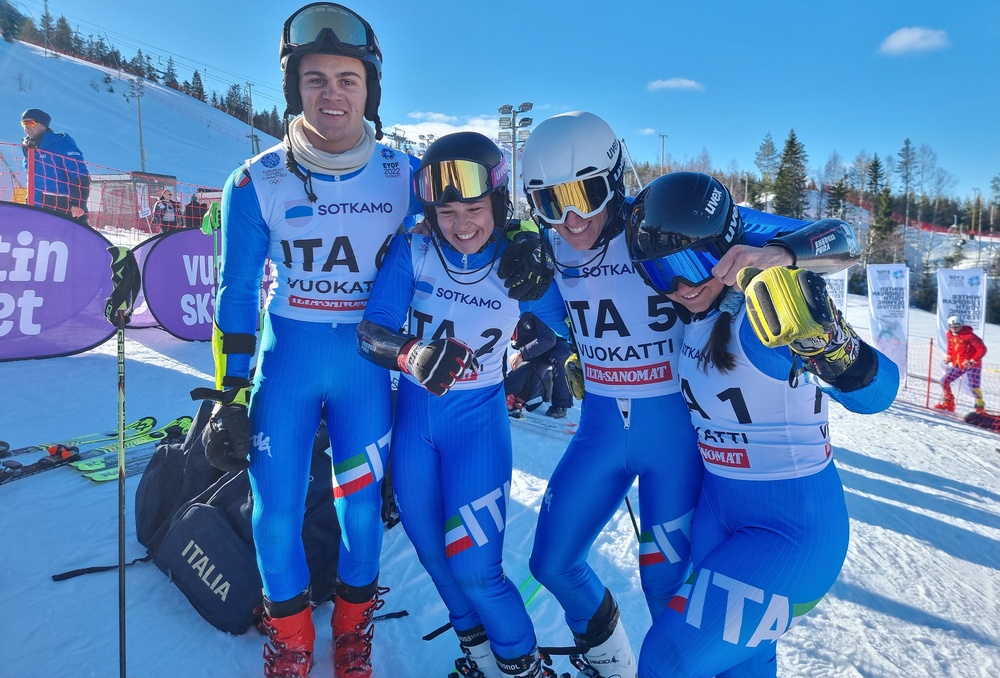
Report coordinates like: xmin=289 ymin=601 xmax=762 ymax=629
xmin=104 ymin=246 xmax=140 ymax=678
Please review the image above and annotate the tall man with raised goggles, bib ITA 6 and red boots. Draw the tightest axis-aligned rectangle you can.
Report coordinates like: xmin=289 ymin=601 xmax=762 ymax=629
xmin=199 ymin=2 xmax=422 ymax=678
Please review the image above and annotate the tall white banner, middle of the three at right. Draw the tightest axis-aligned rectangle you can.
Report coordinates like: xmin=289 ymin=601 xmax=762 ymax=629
xmin=868 ymin=264 xmax=910 ymax=383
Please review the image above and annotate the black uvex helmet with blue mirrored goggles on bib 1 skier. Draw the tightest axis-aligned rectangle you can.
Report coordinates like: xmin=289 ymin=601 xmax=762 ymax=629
xmin=625 ymin=172 xmax=745 ymax=293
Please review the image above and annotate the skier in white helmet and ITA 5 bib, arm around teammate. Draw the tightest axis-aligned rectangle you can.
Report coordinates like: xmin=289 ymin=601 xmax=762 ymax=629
xmin=508 ymin=112 xmax=859 ymax=677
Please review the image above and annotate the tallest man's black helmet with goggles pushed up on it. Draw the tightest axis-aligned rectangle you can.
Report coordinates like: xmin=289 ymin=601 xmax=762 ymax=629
xmin=278 ymin=2 xmax=382 ymax=139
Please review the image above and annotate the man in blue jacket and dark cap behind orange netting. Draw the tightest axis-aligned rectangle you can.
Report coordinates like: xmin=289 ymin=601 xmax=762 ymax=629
xmin=21 ymin=108 xmax=90 ymax=224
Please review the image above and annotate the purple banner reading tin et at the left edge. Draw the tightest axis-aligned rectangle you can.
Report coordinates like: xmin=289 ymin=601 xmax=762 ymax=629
xmin=0 ymin=202 xmax=115 ymax=362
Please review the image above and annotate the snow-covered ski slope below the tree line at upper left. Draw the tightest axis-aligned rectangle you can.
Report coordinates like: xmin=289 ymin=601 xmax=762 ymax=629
xmin=0 ymin=40 xmax=278 ymax=187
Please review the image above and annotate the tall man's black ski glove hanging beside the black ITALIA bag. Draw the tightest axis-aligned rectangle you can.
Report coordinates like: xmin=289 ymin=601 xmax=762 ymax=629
xmin=191 ymin=379 xmax=251 ymax=473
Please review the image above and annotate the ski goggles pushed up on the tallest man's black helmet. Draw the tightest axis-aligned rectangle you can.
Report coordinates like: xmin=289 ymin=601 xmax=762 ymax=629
xmin=281 ymin=2 xmax=379 ymax=57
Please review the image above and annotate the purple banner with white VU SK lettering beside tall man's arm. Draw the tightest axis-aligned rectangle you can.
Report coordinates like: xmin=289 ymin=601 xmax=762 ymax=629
xmin=142 ymin=228 xmax=215 ymax=341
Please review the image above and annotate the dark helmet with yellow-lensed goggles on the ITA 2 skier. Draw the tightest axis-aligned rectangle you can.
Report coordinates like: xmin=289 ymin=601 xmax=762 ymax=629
xmin=413 ymin=132 xmax=514 ymax=240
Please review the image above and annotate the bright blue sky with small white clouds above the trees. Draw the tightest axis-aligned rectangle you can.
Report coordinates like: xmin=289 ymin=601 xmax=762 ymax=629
xmin=14 ymin=0 xmax=1000 ymax=197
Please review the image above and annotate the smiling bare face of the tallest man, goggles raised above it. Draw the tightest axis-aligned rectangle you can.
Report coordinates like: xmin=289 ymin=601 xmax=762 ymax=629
xmin=299 ymin=54 xmax=368 ymax=153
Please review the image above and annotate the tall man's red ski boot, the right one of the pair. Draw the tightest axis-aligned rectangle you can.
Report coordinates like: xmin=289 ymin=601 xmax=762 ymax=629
xmin=330 ymin=580 xmax=389 ymax=678
